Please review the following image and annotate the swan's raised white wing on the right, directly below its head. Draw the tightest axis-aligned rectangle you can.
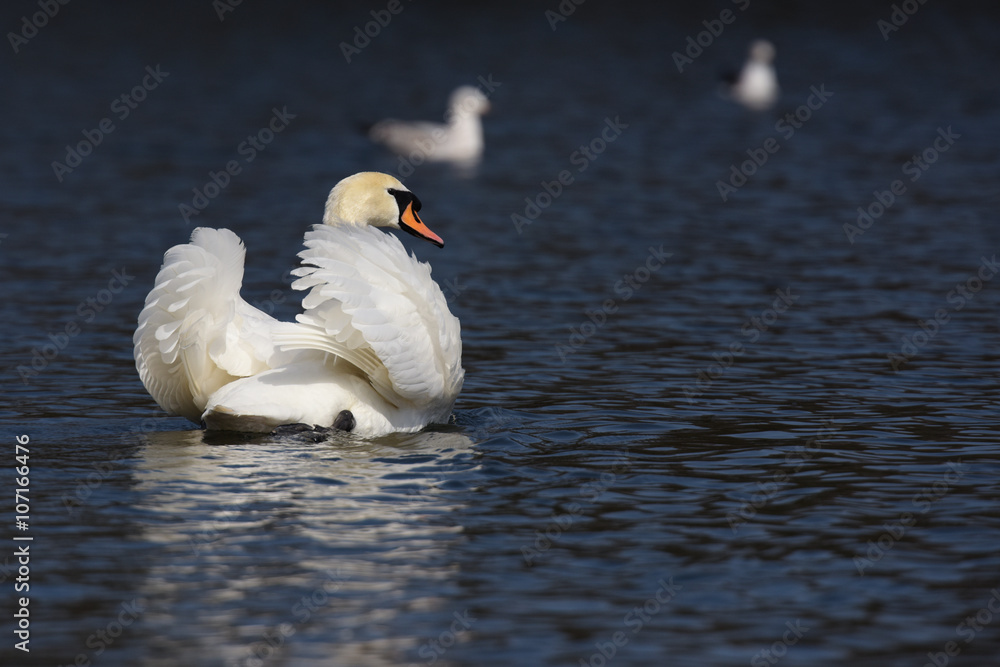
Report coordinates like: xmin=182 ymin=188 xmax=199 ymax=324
xmin=273 ymin=225 xmax=464 ymax=407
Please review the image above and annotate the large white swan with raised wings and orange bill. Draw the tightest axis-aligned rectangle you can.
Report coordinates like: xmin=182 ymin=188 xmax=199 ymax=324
xmin=133 ymin=172 xmax=465 ymax=437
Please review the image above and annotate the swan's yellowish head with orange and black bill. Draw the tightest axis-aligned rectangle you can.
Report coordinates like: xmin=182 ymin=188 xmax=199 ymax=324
xmin=323 ymin=171 xmax=444 ymax=248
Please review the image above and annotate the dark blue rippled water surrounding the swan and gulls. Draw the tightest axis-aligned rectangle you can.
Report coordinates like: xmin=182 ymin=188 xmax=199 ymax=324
xmin=0 ymin=0 xmax=1000 ymax=667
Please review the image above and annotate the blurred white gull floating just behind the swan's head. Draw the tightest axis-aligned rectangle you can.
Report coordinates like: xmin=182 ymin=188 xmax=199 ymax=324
xmin=368 ymin=86 xmax=490 ymax=165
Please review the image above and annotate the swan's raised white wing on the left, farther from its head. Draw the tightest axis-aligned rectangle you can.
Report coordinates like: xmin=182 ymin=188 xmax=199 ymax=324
xmin=133 ymin=227 xmax=276 ymax=422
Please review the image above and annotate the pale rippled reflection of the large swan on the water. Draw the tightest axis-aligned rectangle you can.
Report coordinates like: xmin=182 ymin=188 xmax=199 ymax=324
xmin=136 ymin=431 xmax=477 ymax=665
